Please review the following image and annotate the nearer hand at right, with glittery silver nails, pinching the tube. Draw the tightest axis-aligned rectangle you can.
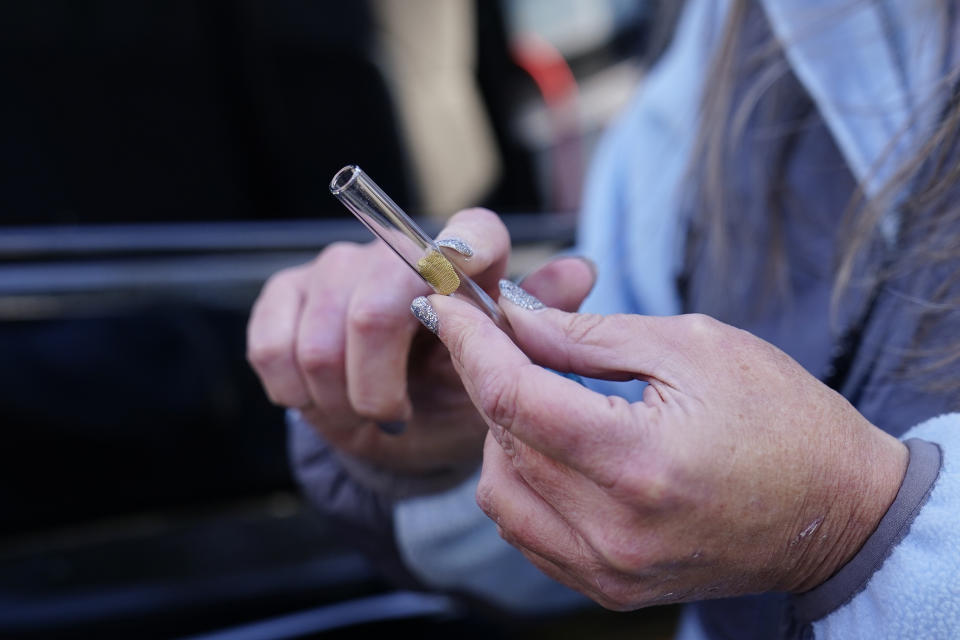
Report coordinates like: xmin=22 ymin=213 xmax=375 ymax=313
xmin=420 ymin=288 xmax=907 ymax=609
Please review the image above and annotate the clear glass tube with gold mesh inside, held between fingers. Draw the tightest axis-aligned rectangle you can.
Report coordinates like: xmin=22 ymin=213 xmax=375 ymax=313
xmin=330 ymin=165 xmax=513 ymax=337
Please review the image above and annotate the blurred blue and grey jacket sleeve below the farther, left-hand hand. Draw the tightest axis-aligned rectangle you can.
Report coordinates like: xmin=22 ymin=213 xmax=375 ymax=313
xmin=287 ymin=411 xmax=588 ymax=614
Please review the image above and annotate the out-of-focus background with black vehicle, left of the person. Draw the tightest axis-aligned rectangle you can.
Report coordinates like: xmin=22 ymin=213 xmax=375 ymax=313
xmin=0 ymin=0 xmax=682 ymax=638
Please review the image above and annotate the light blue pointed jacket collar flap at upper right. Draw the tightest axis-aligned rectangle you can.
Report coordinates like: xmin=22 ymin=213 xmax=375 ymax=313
xmin=762 ymin=0 xmax=951 ymax=197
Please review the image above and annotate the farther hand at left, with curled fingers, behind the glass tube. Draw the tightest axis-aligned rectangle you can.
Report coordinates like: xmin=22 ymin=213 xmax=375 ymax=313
xmin=247 ymin=209 xmax=593 ymax=473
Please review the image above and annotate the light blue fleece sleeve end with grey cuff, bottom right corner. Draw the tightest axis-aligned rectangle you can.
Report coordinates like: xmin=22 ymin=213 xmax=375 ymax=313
xmin=794 ymin=413 xmax=960 ymax=640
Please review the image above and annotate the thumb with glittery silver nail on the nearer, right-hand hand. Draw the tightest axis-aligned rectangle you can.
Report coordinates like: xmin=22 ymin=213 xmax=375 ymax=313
xmin=500 ymin=280 xmax=696 ymax=386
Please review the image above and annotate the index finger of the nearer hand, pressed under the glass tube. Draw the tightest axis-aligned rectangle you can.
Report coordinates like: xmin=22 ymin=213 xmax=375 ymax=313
xmin=430 ymin=295 xmax=647 ymax=485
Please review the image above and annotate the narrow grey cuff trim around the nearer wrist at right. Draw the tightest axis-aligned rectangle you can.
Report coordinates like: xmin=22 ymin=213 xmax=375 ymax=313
xmin=792 ymin=438 xmax=943 ymax=625
